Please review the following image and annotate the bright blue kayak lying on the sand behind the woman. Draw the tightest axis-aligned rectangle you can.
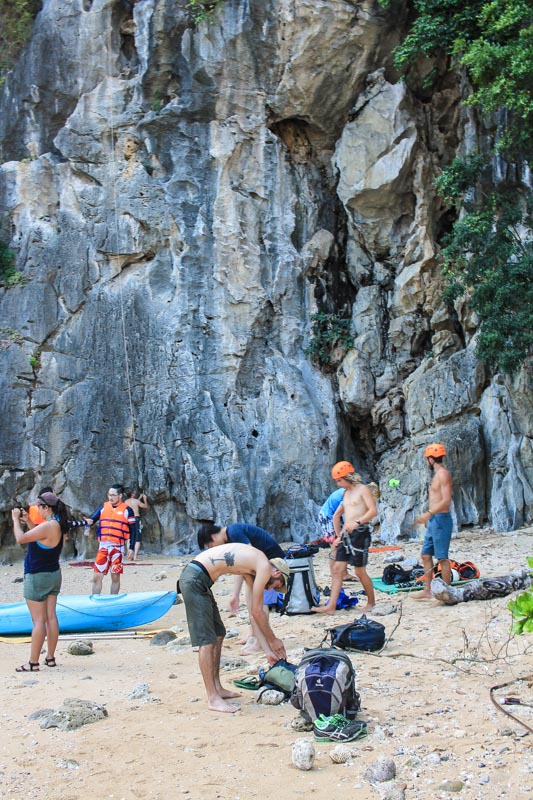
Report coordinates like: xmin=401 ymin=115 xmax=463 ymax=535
xmin=0 ymin=591 xmax=176 ymax=635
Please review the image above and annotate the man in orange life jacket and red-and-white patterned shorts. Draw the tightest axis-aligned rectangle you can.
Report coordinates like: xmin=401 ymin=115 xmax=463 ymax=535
xmin=85 ymin=484 xmax=135 ymax=594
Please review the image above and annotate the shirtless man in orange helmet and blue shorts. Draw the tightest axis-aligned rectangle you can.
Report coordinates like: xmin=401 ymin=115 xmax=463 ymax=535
xmin=413 ymin=443 xmax=452 ymax=600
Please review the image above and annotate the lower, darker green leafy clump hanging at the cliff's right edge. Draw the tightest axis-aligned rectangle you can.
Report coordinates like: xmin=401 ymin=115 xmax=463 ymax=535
xmin=436 ymin=156 xmax=533 ymax=373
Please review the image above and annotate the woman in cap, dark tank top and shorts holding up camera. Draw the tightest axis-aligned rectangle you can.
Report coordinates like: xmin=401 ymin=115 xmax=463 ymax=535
xmin=11 ymin=492 xmax=68 ymax=672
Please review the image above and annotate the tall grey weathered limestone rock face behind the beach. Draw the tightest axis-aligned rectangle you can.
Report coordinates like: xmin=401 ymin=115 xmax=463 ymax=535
xmin=0 ymin=0 xmax=533 ymax=556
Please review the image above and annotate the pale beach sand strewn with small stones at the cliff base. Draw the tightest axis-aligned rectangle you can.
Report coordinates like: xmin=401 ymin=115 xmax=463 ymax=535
xmin=0 ymin=528 xmax=533 ymax=800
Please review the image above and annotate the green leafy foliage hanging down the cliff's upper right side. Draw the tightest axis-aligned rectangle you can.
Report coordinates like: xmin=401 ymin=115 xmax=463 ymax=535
xmin=383 ymin=0 xmax=533 ymax=373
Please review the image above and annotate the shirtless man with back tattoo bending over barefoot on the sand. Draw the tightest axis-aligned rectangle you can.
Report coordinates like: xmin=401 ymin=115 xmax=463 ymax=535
xmin=179 ymin=544 xmax=290 ymax=713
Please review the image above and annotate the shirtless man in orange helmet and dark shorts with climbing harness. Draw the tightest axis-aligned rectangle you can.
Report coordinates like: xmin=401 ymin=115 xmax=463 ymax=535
xmin=312 ymin=461 xmax=378 ymax=614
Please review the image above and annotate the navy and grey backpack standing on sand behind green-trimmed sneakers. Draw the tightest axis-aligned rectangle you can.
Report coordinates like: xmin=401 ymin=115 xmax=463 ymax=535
xmin=291 ymin=647 xmax=361 ymax=722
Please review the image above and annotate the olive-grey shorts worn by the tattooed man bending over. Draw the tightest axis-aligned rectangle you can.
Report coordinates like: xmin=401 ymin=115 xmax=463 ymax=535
xmin=179 ymin=561 xmax=226 ymax=647
